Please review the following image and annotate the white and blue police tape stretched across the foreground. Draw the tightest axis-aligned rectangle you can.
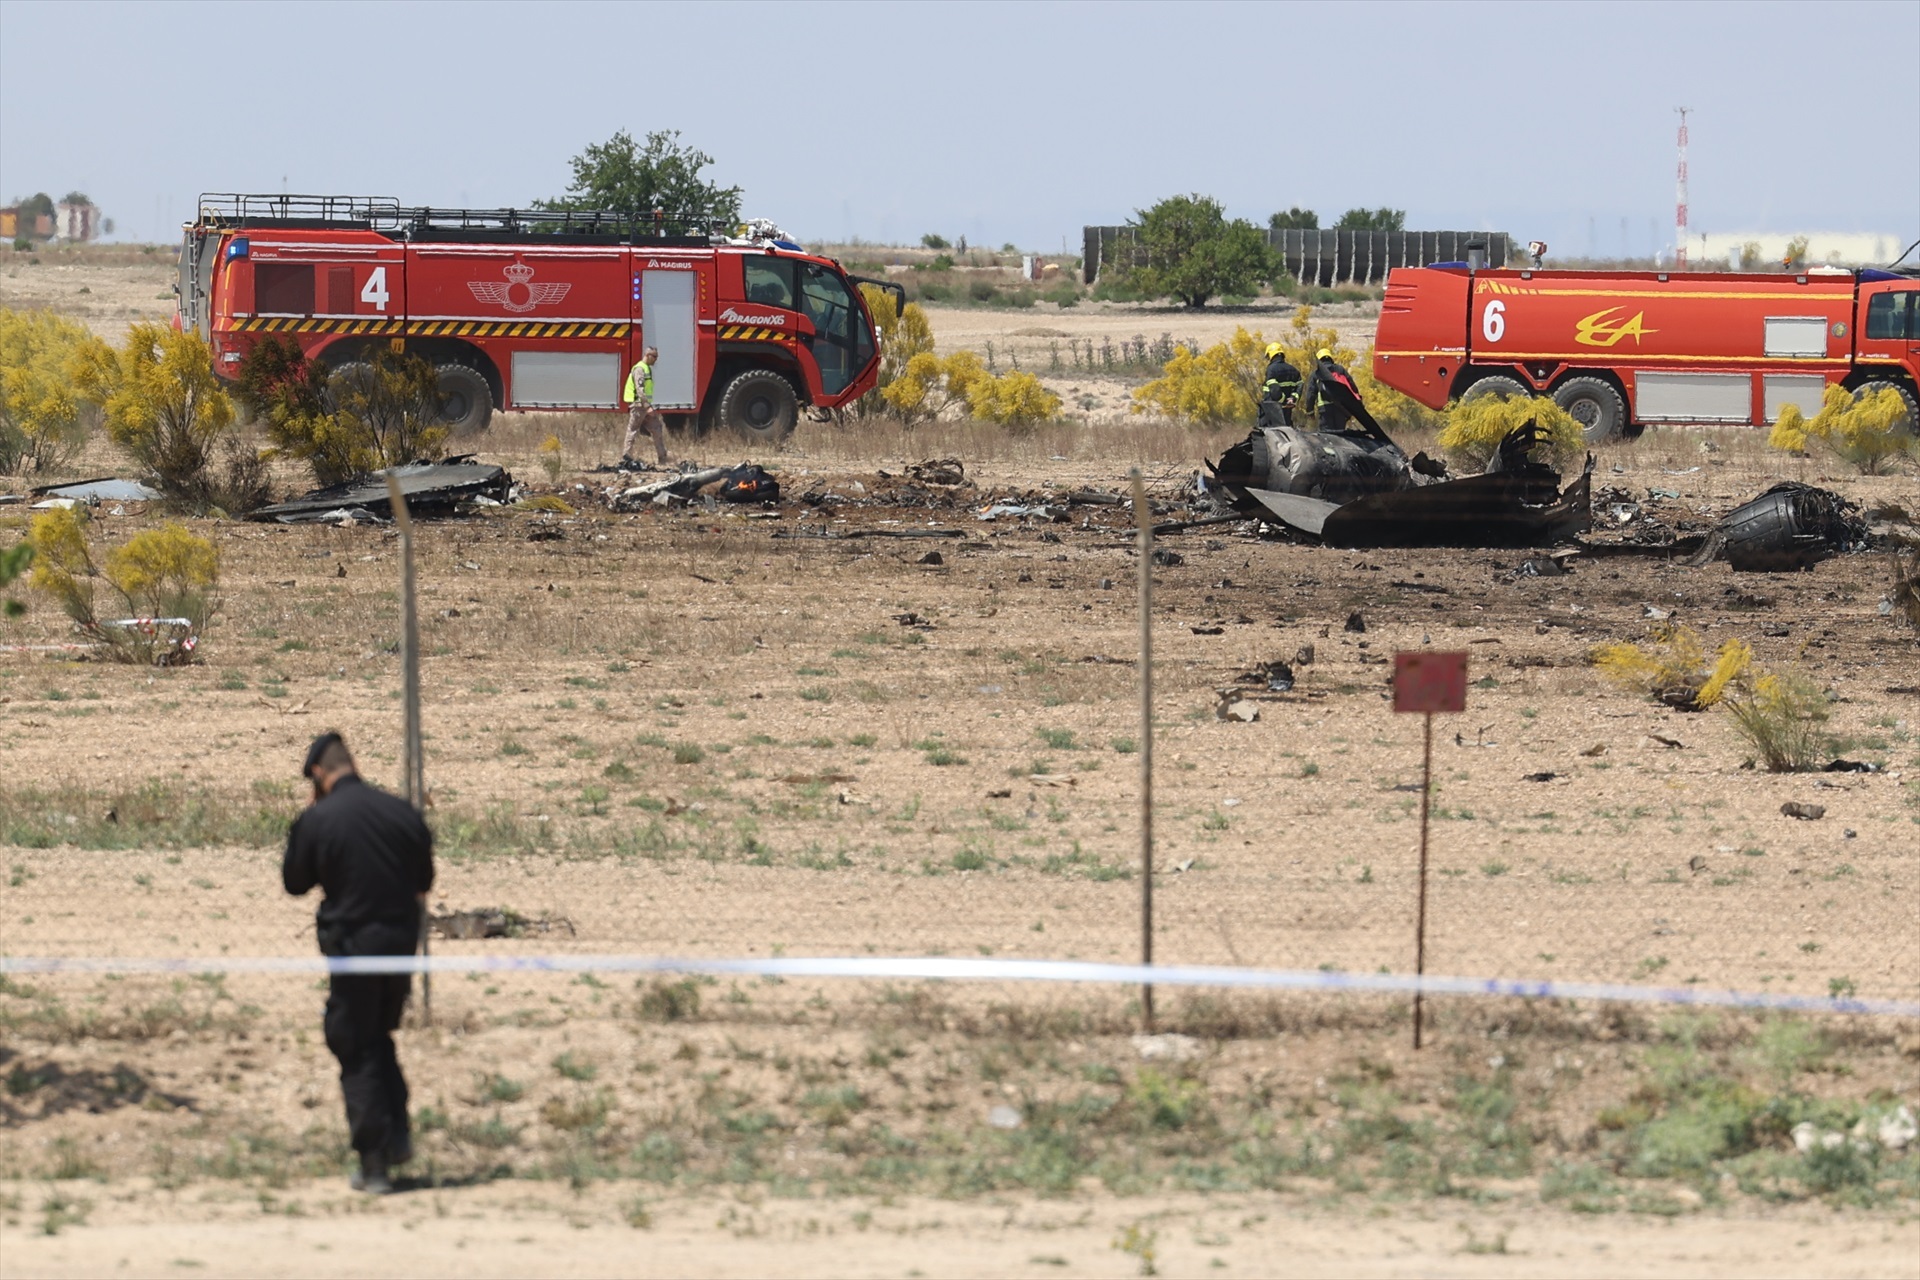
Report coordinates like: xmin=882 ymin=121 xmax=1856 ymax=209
xmin=0 ymin=954 xmax=1920 ymax=1017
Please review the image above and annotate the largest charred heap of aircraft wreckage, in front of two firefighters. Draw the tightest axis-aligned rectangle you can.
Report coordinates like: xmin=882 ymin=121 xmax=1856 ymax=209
xmin=1210 ymin=422 xmax=1594 ymax=547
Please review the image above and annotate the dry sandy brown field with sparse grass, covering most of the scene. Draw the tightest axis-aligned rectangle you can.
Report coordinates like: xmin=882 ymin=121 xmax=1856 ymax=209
xmin=0 ymin=263 xmax=1920 ymax=1276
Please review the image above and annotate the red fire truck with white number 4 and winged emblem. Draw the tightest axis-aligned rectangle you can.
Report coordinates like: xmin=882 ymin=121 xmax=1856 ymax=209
xmin=177 ymin=196 xmax=900 ymax=443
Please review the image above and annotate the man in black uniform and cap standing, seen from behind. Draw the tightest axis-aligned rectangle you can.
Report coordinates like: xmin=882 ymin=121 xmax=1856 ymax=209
xmin=280 ymin=733 xmax=434 ymax=1196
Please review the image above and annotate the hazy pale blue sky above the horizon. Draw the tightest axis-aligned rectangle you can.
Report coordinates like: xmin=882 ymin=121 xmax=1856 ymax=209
xmin=0 ymin=0 xmax=1920 ymax=257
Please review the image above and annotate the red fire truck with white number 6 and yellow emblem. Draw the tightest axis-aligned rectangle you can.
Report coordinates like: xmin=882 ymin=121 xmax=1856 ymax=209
xmin=1373 ymin=263 xmax=1920 ymax=443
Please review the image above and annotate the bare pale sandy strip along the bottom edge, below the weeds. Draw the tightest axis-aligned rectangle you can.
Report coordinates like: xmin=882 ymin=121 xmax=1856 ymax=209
xmin=0 ymin=1184 xmax=1920 ymax=1278
